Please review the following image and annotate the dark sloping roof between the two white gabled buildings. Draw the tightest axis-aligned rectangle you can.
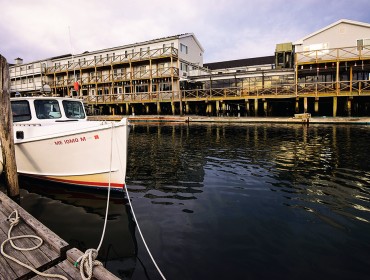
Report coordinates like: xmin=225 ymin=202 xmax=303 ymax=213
xmin=203 ymin=55 xmax=275 ymax=70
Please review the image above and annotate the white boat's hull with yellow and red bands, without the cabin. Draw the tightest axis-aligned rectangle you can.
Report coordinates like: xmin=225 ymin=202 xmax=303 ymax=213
xmin=15 ymin=120 xmax=129 ymax=190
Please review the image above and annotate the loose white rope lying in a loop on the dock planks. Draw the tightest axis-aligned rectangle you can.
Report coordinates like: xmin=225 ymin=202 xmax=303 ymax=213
xmin=1 ymin=210 xmax=68 ymax=280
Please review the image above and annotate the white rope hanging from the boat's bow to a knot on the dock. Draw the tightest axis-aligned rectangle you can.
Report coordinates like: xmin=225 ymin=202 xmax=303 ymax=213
xmin=74 ymin=122 xmax=114 ymax=280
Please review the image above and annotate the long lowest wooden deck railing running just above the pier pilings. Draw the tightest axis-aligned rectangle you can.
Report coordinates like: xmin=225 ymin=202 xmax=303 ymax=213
xmin=75 ymin=80 xmax=370 ymax=104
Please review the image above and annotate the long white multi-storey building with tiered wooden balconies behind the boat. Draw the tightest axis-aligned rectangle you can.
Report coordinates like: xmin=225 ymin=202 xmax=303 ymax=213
xmin=10 ymin=33 xmax=204 ymax=96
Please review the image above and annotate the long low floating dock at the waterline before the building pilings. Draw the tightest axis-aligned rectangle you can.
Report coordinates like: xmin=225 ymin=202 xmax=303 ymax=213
xmin=88 ymin=115 xmax=370 ymax=125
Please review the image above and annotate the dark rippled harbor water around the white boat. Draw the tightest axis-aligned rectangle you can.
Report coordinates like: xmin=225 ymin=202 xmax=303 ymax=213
xmin=2 ymin=123 xmax=370 ymax=280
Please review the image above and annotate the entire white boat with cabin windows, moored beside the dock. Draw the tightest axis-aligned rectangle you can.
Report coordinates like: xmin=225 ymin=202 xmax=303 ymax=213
xmin=0 ymin=97 xmax=129 ymax=190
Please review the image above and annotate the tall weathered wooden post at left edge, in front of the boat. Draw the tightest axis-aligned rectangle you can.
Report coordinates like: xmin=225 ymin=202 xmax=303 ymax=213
xmin=0 ymin=55 xmax=19 ymax=198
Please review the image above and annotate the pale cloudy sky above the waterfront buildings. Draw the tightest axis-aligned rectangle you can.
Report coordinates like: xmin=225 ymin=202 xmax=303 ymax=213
xmin=0 ymin=0 xmax=370 ymax=63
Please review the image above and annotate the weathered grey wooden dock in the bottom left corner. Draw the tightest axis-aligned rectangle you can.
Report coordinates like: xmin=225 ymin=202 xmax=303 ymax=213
xmin=0 ymin=192 xmax=119 ymax=280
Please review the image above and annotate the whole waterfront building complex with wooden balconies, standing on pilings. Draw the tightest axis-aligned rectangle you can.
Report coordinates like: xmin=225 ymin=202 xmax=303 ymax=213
xmin=10 ymin=20 xmax=370 ymax=116
